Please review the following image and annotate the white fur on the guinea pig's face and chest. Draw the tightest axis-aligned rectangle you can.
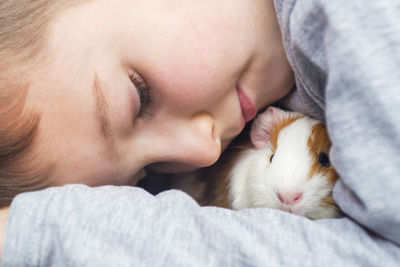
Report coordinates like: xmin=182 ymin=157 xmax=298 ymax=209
xmin=229 ymin=113 xmax=337 ymax=218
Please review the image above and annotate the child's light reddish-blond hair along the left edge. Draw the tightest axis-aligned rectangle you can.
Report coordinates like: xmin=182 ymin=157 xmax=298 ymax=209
xmin=0 ymin=0 xmax=88 ymax=207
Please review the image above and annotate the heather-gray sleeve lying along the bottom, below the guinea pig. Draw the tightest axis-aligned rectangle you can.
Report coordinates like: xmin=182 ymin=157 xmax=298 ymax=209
xmin=2 ymin=185 xmax=400 ymax=267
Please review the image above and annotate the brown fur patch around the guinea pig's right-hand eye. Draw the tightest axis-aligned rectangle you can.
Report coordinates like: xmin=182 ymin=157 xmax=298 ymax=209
xmin=307 ymin=123 xmax=338 ymax=184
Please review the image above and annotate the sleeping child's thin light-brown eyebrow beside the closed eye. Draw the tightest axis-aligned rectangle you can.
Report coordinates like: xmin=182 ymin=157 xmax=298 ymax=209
xmin=92 ymin=74 xmax=118 ymax=162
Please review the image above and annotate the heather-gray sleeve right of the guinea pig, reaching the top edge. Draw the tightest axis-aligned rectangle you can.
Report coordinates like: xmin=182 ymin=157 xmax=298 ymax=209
xmin=275 ymin=0 xmax=400 ymax=245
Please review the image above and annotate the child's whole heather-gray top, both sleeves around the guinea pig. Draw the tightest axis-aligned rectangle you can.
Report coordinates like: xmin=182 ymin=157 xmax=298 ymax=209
xmin=3 ymin=0 xmax=400 ymax=266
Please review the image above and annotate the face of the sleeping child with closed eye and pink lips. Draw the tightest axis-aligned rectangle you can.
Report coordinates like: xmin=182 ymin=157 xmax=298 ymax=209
xmin=27 ymin=0 xmax=293 ymax=185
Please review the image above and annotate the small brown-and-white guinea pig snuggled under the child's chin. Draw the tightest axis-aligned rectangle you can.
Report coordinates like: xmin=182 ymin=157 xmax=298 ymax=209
xmin=174 ymin=107 xmax=341 ymax=219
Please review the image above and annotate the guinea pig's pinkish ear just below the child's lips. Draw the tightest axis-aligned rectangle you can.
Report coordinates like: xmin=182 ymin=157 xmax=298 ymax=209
xmin=250 ymin=107 xmax=286 ymax=148
